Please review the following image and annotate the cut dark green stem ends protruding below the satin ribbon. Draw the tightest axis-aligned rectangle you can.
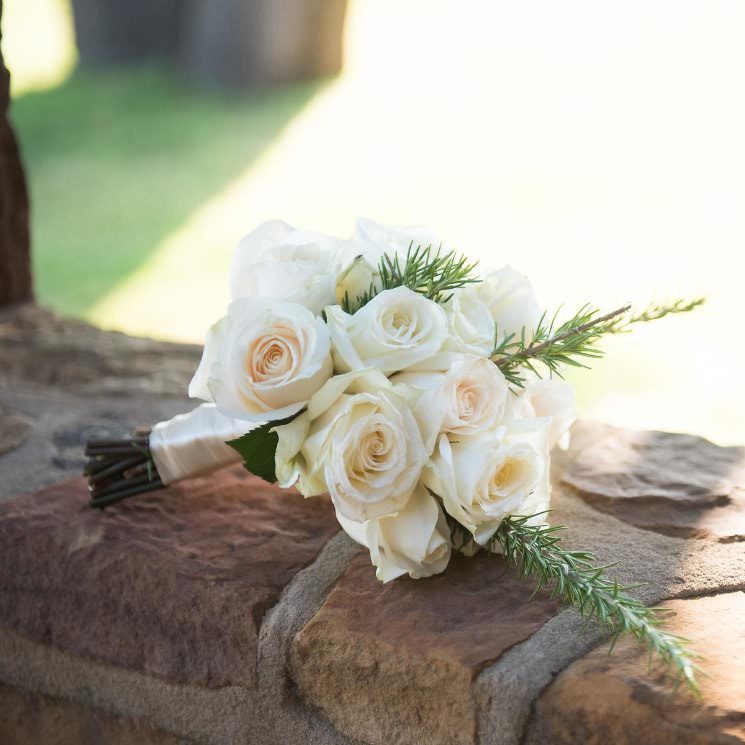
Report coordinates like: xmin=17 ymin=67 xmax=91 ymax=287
xmin=83 ymin=430 xmax=164 ymax=509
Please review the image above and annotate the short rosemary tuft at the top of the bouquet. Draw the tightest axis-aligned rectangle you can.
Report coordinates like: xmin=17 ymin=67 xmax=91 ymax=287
xmin=342 ymin=242 xmax=481 ymax=314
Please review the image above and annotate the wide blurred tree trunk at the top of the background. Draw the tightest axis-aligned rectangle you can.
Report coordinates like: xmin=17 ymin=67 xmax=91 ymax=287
xmin=72 ymin=0 xmax=346 ymax=88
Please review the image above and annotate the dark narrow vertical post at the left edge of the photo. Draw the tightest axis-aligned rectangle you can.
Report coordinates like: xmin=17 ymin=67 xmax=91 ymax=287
xmin=0 ymin=0 xmax=32 ymax=305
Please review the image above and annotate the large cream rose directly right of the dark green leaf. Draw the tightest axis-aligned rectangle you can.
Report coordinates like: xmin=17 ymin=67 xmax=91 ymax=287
xmin=275 ymin=370 xmax=427 ymax=522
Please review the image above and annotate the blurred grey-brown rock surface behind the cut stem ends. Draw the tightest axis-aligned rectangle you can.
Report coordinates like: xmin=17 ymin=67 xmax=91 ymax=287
xmin=0 ymin=306 xmax=201 ymax=499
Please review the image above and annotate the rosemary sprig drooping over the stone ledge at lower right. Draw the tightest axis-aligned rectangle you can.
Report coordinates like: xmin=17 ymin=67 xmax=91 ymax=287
xmin=494 ymin=517 xmax=698 ymax=693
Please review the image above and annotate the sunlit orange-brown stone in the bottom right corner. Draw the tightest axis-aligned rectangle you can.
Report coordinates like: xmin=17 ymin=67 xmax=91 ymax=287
xmin=529 ymin=592 xmax=745 ymax=745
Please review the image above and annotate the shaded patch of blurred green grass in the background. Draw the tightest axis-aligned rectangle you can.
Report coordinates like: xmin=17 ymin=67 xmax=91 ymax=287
xmin=11 ymin=69 xmax=319 ymax=315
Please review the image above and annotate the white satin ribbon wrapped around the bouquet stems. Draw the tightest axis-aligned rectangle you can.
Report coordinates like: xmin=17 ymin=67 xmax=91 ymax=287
xmin=150 ymin=404 xmax=261 ymax=484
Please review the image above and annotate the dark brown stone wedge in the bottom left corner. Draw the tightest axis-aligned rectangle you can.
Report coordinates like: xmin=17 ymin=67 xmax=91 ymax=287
xmin=0 ymin=685 xmax=188 ymax=745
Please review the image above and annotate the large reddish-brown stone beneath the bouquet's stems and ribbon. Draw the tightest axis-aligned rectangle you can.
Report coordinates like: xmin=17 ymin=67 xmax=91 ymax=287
xmin=0 ymin=466 xmax=338 ymax=687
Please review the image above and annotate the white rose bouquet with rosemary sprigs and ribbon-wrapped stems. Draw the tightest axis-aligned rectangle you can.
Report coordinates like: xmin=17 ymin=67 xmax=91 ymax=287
xmin=87 ymin=219 xmax=702 ymax=688
